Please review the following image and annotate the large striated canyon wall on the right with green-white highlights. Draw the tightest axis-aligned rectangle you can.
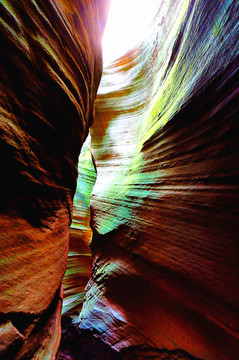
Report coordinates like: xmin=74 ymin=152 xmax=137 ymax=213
xmin=79 ymin=0 xmax=239 ymax=360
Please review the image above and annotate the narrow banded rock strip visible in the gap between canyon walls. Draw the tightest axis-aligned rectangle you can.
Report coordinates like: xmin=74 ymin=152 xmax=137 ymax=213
xmin=62 ymin=136 xmax=96 ymax=317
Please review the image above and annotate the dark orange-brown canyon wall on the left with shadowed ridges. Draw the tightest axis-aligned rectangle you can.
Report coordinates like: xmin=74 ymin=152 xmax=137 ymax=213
xmin=0 ymin=0 xmax=109 ymax=360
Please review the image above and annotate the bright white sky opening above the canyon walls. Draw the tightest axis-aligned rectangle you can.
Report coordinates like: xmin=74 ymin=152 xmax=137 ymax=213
xmin=102 ymin=0 xmax=159 ymax=66
